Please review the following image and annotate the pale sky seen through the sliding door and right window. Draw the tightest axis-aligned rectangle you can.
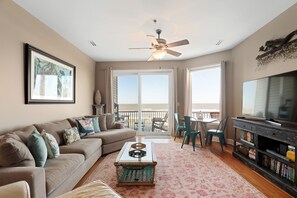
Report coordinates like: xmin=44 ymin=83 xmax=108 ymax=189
xmin=118 ymin=67 xmax=220 ymax=104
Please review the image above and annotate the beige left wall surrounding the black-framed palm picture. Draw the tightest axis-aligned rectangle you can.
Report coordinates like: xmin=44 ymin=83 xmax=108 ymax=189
xmin=0 ymin=0 xmax=95 ymax=131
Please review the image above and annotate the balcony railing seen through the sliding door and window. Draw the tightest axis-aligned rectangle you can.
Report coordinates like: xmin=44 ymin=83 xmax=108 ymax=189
xmin=119 ymin=110 xmax=220 ymax=131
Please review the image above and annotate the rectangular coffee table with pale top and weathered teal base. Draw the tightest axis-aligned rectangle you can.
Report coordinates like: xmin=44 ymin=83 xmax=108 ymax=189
xmin=114 ymin=142 xmax=157 ymax=186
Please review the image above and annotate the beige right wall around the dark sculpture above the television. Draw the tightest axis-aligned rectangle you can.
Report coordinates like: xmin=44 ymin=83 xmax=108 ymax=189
xmin=232 ymin=4 xmax=297 ymax=116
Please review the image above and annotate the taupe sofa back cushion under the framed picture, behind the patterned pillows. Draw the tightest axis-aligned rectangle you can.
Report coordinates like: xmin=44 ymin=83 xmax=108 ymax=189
xmin=34 ymin=120 xmax=71 ymax=145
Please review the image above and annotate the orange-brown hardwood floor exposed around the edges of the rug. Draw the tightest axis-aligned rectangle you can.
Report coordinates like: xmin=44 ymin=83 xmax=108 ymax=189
xmin=75 ymin=138 xmax=293 ymax=198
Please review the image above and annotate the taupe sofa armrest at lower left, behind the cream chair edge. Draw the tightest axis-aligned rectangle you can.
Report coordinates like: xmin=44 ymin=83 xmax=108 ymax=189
xmin=0 ymin=167 xmax=46 ymax=198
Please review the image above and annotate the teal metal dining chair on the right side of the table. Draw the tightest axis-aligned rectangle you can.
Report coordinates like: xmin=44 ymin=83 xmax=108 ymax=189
xmin=205 ymin=117 xmax=228 ymax=151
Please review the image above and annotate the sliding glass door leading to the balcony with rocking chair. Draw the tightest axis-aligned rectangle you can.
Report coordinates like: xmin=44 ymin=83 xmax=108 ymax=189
xmin=113 ymin=71 xmax=171 ymax=135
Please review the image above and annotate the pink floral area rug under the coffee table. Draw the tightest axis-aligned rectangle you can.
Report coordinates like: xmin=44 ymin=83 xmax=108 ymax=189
xmin=85 ymin=141 xmax=265 ymax=198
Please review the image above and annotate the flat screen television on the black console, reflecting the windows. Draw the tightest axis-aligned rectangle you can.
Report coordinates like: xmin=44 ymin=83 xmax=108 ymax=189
xmin=242 ymin=71 xmax=297 ymax=123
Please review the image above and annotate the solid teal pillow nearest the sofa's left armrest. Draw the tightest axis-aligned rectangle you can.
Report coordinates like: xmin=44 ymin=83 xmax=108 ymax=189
xmin=28 ymin=130 xmax=47 ymax=167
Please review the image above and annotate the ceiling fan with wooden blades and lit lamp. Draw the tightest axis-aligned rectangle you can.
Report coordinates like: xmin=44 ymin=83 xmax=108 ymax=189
xmin=129 ymin=29 xmax=189 ymax=61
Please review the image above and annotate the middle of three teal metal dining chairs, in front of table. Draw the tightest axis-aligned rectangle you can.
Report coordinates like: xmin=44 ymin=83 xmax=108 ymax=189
xmin=181 ymin=116 xmax=202 ymax=151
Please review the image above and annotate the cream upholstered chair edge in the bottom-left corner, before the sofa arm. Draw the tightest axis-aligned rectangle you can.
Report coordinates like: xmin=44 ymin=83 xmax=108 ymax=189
xmin=0 ymin=181 xmax=30 ymax=198
